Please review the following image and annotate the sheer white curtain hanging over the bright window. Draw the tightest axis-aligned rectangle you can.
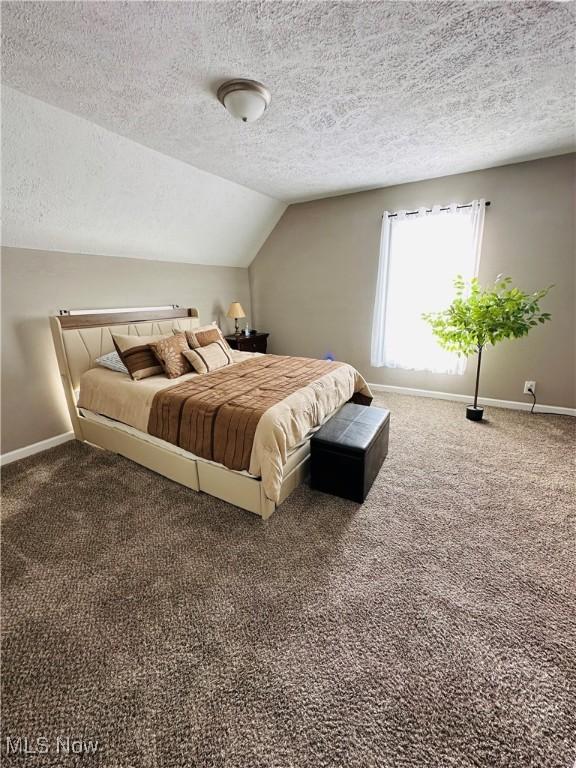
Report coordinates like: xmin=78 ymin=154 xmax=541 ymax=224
xmin=371 ymin=200 xmax=485 ymax=374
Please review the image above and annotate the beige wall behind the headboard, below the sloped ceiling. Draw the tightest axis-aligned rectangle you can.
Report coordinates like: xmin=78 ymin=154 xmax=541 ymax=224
xmin=2 ymin=248 xmax=250 ymax=453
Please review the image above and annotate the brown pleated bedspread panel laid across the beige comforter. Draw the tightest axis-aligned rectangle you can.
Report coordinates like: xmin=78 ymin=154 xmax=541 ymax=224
xmin=148 ymin=355 xmax=371 ymax=470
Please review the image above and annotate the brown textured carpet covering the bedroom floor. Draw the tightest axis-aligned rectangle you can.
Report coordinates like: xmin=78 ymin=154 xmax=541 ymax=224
xmin=2 ymin=395 xmax=576 ymax=768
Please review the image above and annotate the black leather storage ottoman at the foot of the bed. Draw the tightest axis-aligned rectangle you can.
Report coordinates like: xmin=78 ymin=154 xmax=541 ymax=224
xmin=310 ymin=403 xmax=390 ymax=502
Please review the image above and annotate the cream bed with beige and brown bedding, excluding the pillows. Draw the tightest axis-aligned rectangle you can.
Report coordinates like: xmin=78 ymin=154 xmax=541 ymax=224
xmin=51 ymin=308 xmax=371 ymax=519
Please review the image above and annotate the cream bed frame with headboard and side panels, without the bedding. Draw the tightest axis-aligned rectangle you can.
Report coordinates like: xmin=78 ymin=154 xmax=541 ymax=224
xmin=50 ymin=307 xmax=310 ymax=519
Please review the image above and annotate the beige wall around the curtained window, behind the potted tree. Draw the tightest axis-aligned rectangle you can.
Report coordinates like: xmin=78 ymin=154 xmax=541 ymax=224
xmin=250 ymin=155 xmax=576 ymax=407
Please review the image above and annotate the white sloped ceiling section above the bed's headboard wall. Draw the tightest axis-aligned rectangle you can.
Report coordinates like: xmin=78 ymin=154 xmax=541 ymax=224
xmin=2 ymin=86 xmax=286 ymax=267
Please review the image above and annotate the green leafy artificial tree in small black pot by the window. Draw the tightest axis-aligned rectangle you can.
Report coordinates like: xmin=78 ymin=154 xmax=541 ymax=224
xmin=422 ymin=275 xmax=552 ymax=421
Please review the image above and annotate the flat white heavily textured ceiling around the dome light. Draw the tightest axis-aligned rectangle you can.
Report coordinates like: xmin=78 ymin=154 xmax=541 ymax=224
xmin=2 ymin=0 xmax=575 ymax=201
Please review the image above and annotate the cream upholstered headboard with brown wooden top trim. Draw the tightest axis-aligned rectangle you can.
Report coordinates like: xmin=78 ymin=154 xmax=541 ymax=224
xmin=50 ymin=307 xmax=200 ymax=435
